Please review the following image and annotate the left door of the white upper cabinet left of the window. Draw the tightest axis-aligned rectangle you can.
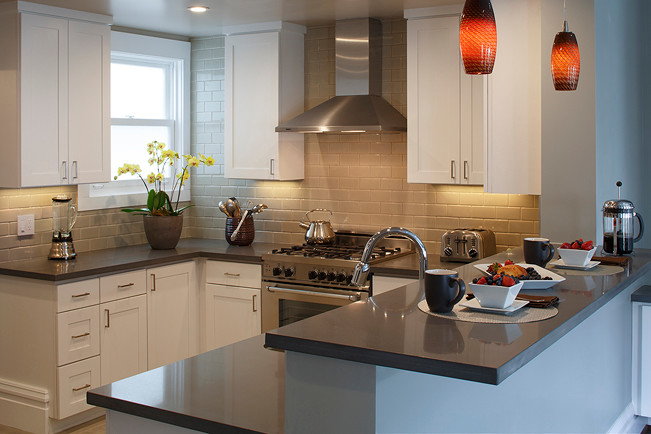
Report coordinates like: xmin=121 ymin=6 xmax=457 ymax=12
xmin=19 ymin=14 xmax=68 ymax=187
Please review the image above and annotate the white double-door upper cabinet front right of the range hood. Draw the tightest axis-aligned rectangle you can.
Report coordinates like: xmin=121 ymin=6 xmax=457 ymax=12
xmin=405 ymin=7 xmax=485 ymax=185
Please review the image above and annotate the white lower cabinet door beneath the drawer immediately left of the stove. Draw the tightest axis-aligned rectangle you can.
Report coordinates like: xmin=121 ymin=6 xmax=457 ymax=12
xmin=204 ymin=284 xmax=261 ymax=350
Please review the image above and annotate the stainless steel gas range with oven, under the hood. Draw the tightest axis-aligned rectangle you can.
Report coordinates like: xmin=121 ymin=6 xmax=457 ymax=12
xmin=262 ymin=233 xmax=413 ymax=332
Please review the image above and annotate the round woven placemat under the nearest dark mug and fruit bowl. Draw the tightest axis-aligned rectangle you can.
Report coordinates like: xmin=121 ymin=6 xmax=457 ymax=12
xmin=418 ymin=300 xmax=558 ymax=324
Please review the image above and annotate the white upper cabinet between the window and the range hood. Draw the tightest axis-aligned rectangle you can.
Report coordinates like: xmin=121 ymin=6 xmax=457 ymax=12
xmin=224 ymin=23 xmax=305 ymax=180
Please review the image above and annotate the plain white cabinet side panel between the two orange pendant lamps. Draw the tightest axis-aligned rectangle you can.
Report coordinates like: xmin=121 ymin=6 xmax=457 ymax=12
xmin=484 ymin=0 xmax=551 ymax=195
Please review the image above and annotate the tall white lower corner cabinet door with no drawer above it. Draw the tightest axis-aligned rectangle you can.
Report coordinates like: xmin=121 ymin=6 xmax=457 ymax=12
xmin=147 ymin=262 xmax=199 ymax=369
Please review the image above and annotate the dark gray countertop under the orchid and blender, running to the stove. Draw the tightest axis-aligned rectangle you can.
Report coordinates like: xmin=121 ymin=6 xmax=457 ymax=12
xmin=0 ymin=238 xmax=285 ymax=282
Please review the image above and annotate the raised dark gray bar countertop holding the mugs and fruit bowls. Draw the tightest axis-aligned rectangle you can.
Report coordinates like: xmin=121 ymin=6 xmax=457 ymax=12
xmin=266 ymin=248 xmax=651 ymax=384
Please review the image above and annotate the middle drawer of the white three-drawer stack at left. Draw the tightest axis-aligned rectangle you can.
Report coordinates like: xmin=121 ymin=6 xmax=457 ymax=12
xmin=57 ymin=306 xmax=99 ymax=366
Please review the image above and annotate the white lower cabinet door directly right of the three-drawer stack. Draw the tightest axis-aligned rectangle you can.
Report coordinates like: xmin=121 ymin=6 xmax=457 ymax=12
xmin=100 ymin=294 xmax=147 ymax=384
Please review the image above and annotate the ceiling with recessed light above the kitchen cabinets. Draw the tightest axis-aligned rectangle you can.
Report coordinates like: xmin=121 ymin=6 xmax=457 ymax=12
xmin=5 ymin=0 xmax=463 ymax=37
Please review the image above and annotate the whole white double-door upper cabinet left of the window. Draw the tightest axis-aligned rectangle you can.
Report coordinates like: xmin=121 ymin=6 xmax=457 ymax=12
xmin=0 ymin=2 xmax=111 ymax=187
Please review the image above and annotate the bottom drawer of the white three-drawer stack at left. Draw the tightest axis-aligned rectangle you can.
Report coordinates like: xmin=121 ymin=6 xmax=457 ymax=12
xmin=56 ymin=356 xmax=100 ymax=419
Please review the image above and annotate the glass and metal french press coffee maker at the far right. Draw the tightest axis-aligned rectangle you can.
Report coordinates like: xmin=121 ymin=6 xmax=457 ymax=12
xmin=601 ymin=181 xmax=644 ymax=255
